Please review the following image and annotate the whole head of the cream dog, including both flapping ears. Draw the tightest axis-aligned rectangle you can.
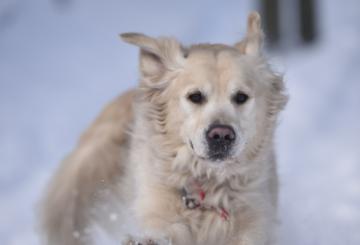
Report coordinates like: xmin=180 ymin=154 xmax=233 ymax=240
xmin=121 ymin=13 xmax=286 ymax=167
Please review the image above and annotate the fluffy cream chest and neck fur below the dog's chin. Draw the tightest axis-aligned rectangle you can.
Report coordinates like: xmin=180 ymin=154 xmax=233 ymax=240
xmin=129 ymin=107 xmax=276 ymax=244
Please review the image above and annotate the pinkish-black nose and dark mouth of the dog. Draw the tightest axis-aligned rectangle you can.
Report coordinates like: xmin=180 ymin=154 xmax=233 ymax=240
xmin=206 ymin=124 xmax=236 ymax=160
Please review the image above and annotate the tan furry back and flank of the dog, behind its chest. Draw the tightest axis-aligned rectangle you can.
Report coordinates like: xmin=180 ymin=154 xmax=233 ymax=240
xmin=41 ymin=91 xmax=134 ymax=245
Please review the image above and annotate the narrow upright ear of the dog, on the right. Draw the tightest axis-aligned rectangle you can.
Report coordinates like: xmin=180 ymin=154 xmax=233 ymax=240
xmin=235 ymin=12 xmax=264 ymax=56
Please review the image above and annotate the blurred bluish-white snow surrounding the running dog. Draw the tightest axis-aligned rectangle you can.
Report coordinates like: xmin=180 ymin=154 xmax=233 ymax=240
xmin=0 ymin=0 xmax=360 ymax=245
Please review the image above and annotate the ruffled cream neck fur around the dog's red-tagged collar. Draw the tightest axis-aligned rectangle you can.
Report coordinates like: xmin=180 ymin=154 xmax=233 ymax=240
xmin=145 ymin=130 xmax=264 ymax=220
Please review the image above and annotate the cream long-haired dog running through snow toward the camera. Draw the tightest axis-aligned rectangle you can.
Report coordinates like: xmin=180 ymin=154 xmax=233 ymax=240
xmin=41 ymin=12 xmax=287 ymax=245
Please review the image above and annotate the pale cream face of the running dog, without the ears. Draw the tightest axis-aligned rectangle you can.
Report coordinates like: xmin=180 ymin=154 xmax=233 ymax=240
xmin=174 ymin=46 xmax=265 ymax=162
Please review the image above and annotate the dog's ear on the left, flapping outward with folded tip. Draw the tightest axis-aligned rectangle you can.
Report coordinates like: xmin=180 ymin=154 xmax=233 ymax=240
xmin=120 ymin=33 xmax=184 ymax=87
